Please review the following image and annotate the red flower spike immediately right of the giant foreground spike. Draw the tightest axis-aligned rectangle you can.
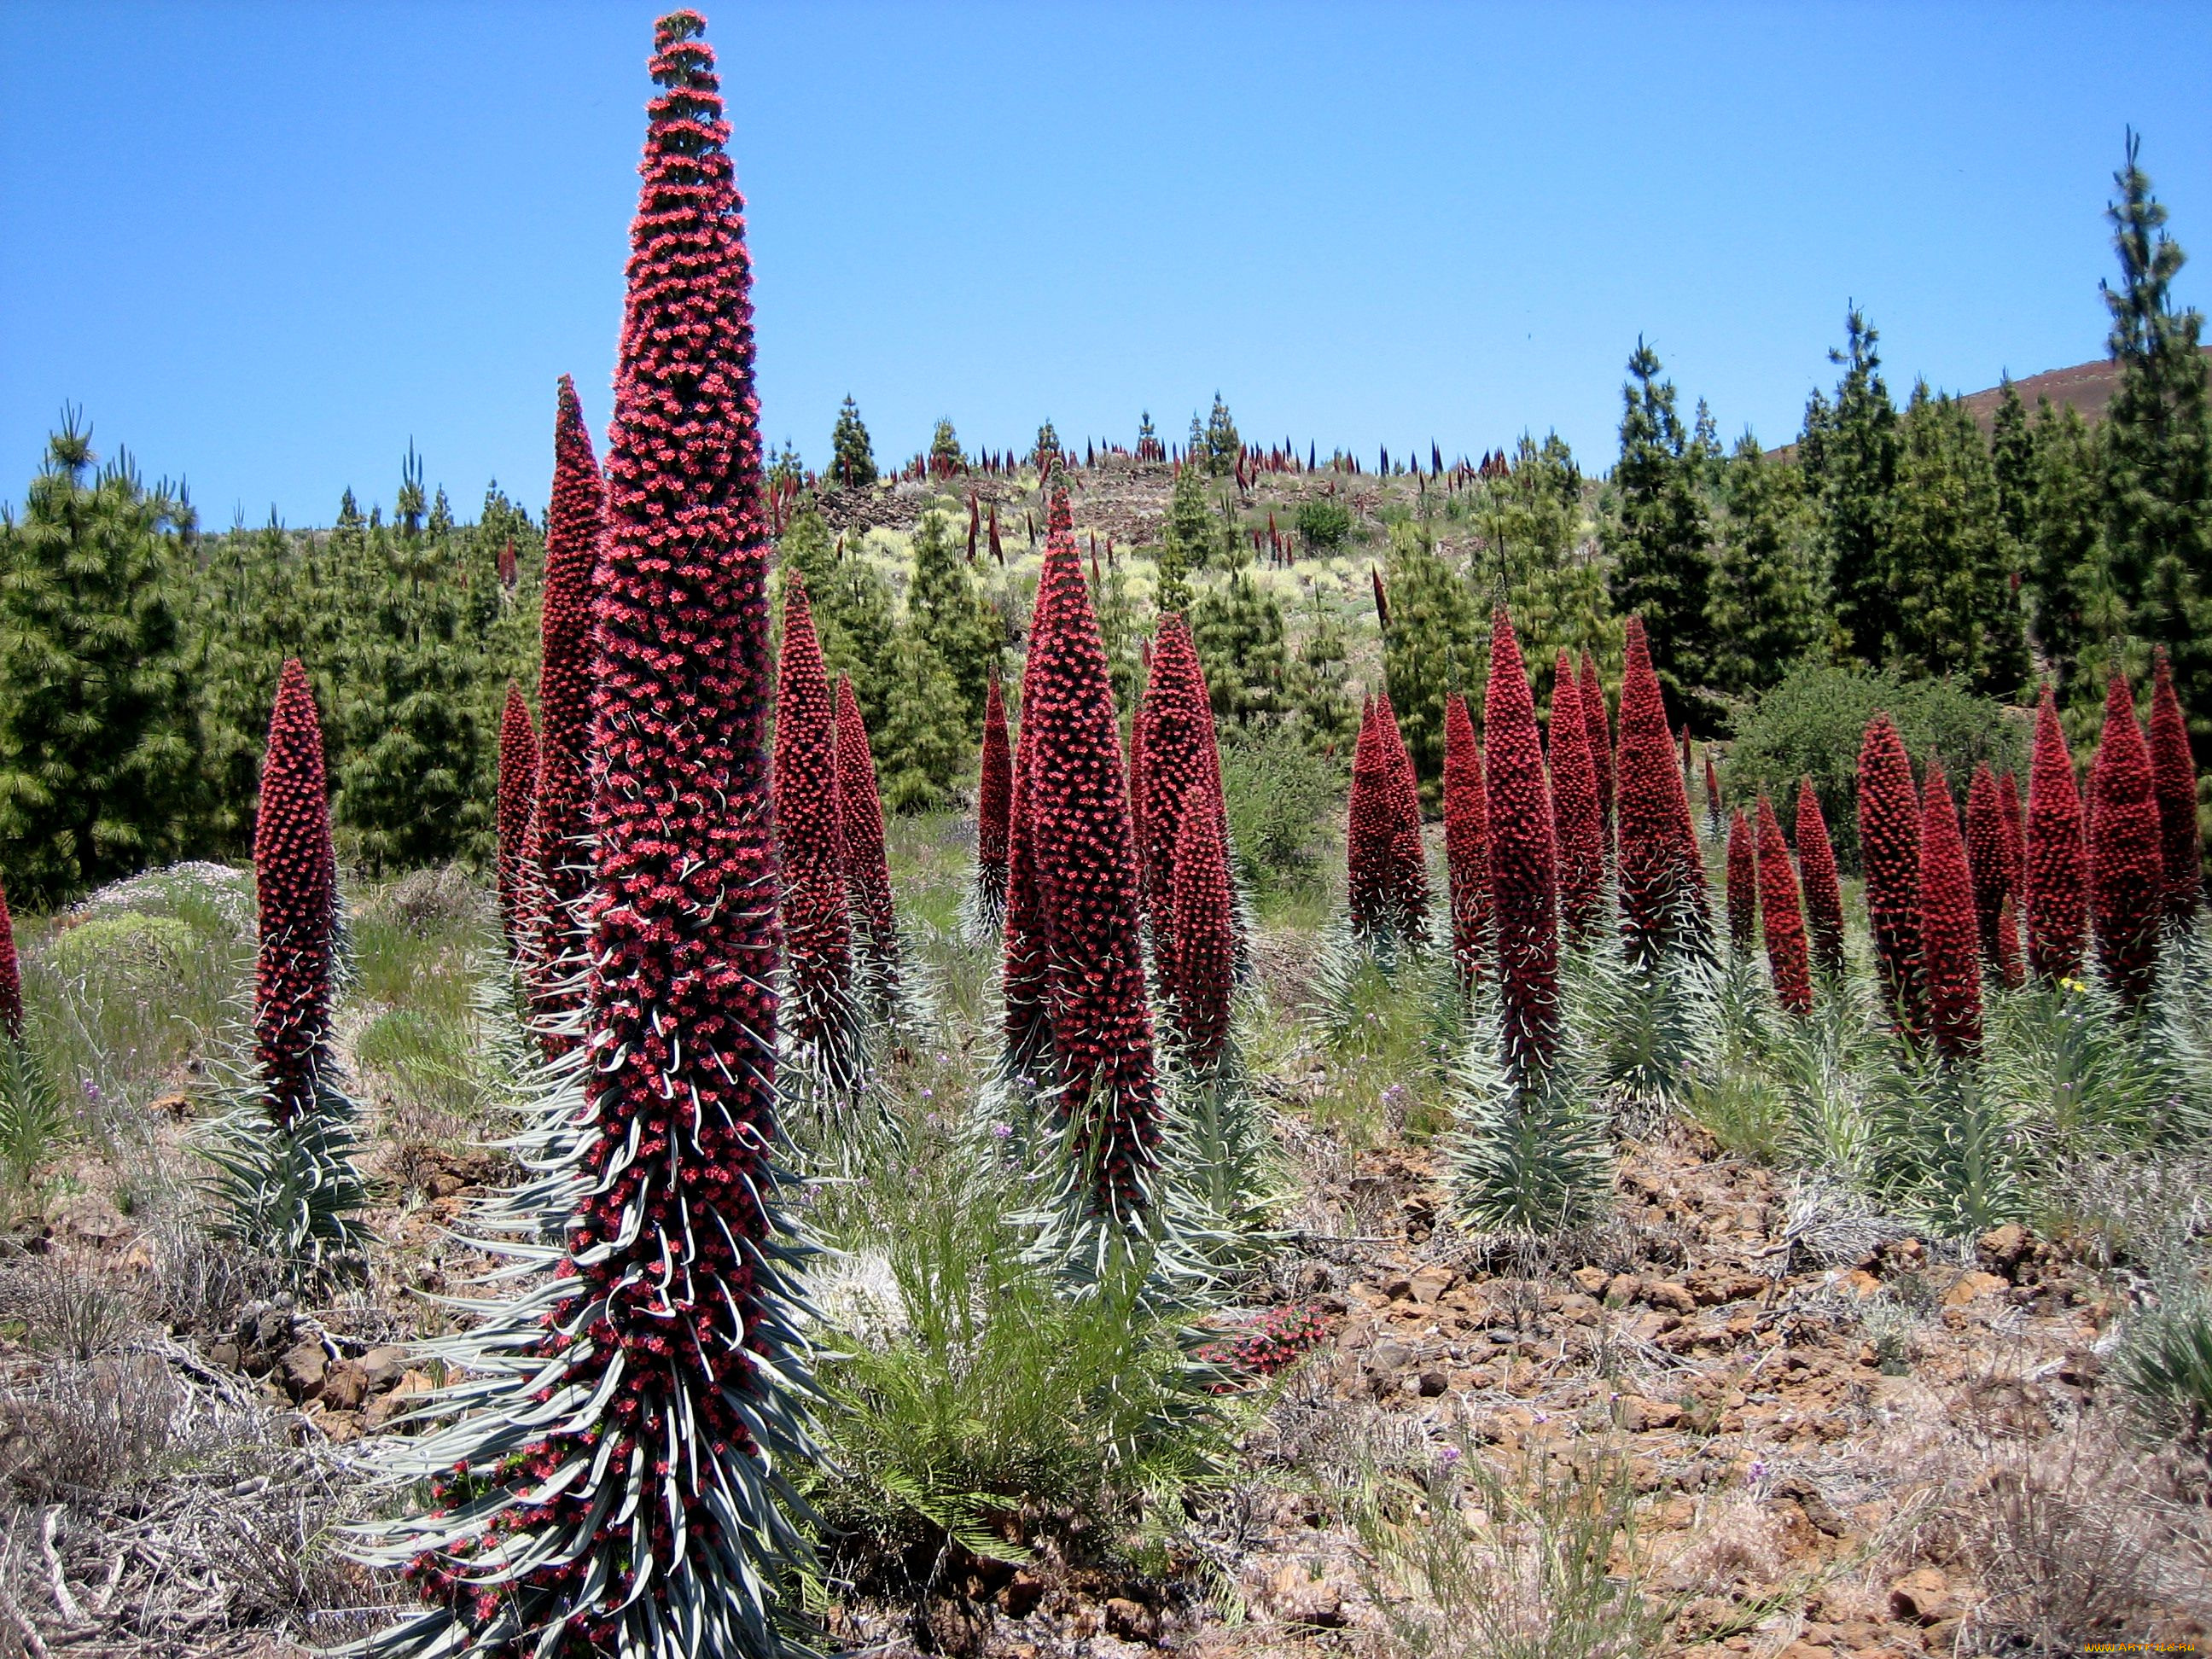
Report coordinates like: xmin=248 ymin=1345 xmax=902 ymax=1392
xmin=777 ymin=571 xmax=849 ymax=1066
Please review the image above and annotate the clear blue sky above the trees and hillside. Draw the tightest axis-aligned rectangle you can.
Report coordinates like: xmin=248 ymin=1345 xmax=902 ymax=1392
xmin=0 ymin=0 xmax=2212 ymax=528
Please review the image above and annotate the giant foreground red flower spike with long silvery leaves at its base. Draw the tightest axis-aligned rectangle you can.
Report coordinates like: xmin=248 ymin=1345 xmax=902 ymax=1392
xmin=376 ymin=11 xmax=816 ymax=1659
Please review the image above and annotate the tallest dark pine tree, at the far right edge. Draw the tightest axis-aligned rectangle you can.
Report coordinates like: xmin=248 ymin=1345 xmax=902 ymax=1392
xmin=2104 ymin=133 xmax=2212 ymax=763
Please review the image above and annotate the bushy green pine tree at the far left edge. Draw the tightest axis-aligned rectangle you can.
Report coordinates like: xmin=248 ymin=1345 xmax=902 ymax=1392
xmin=0 ymin=414 xmax=199 ymax=907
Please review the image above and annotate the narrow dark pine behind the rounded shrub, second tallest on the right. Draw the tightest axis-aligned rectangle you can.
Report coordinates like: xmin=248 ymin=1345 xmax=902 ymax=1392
xmin=1801 ymin=306 xmax=1898 ymax=668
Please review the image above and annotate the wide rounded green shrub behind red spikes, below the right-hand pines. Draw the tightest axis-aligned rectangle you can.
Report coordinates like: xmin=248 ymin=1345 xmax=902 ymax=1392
xmin=1727 ymin=668 xmax=2029 ymax=871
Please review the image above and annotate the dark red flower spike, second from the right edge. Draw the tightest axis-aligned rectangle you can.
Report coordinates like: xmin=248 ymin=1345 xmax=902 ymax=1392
xmin=2088 ymin=672 xmax=2166 ymax=1006
